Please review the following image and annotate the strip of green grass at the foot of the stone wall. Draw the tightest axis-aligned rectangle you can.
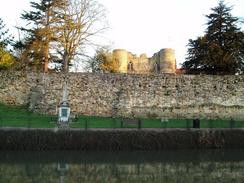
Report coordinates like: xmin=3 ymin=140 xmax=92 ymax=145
xmin=0 ymin=104 xmax=244 ymax=129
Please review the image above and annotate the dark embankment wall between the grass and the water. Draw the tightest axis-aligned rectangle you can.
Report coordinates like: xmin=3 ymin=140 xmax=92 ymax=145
xmin=0 ymin=128 xmax=244 ymax=151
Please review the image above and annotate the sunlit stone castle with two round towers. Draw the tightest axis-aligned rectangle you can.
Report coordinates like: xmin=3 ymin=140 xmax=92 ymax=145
xmin=113 ymin=48 xmax=176 ymax=74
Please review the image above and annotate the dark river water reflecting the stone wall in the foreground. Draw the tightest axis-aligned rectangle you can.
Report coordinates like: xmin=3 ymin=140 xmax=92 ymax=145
xmin=0 ymin=150 xmax=244 ymax=183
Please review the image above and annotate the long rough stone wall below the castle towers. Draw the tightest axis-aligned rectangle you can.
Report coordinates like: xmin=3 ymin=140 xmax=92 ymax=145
xmin=0 ymin=73 xmax=244 ymax=118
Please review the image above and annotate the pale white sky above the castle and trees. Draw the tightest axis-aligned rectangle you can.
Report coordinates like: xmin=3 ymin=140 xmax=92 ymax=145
xmin=0 ymin=0 xmax=244 ymax=67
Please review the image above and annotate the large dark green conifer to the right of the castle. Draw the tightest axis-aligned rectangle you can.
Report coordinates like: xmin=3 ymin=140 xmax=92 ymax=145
xmin=183 ymin=1 xmax=244 ymax=74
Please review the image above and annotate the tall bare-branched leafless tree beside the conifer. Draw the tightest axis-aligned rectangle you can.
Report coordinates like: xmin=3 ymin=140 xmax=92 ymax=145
xmin=55 ymin=0 xmax=105 ymax=72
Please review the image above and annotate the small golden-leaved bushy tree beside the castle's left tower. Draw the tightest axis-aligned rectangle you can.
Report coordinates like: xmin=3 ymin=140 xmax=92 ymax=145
xmin=85 ymin=47 xmax=119 ymax=73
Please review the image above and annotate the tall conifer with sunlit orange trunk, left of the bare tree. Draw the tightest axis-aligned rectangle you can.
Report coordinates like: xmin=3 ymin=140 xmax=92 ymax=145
xmin=18 ymin=0 xmax=63 ymax=72
